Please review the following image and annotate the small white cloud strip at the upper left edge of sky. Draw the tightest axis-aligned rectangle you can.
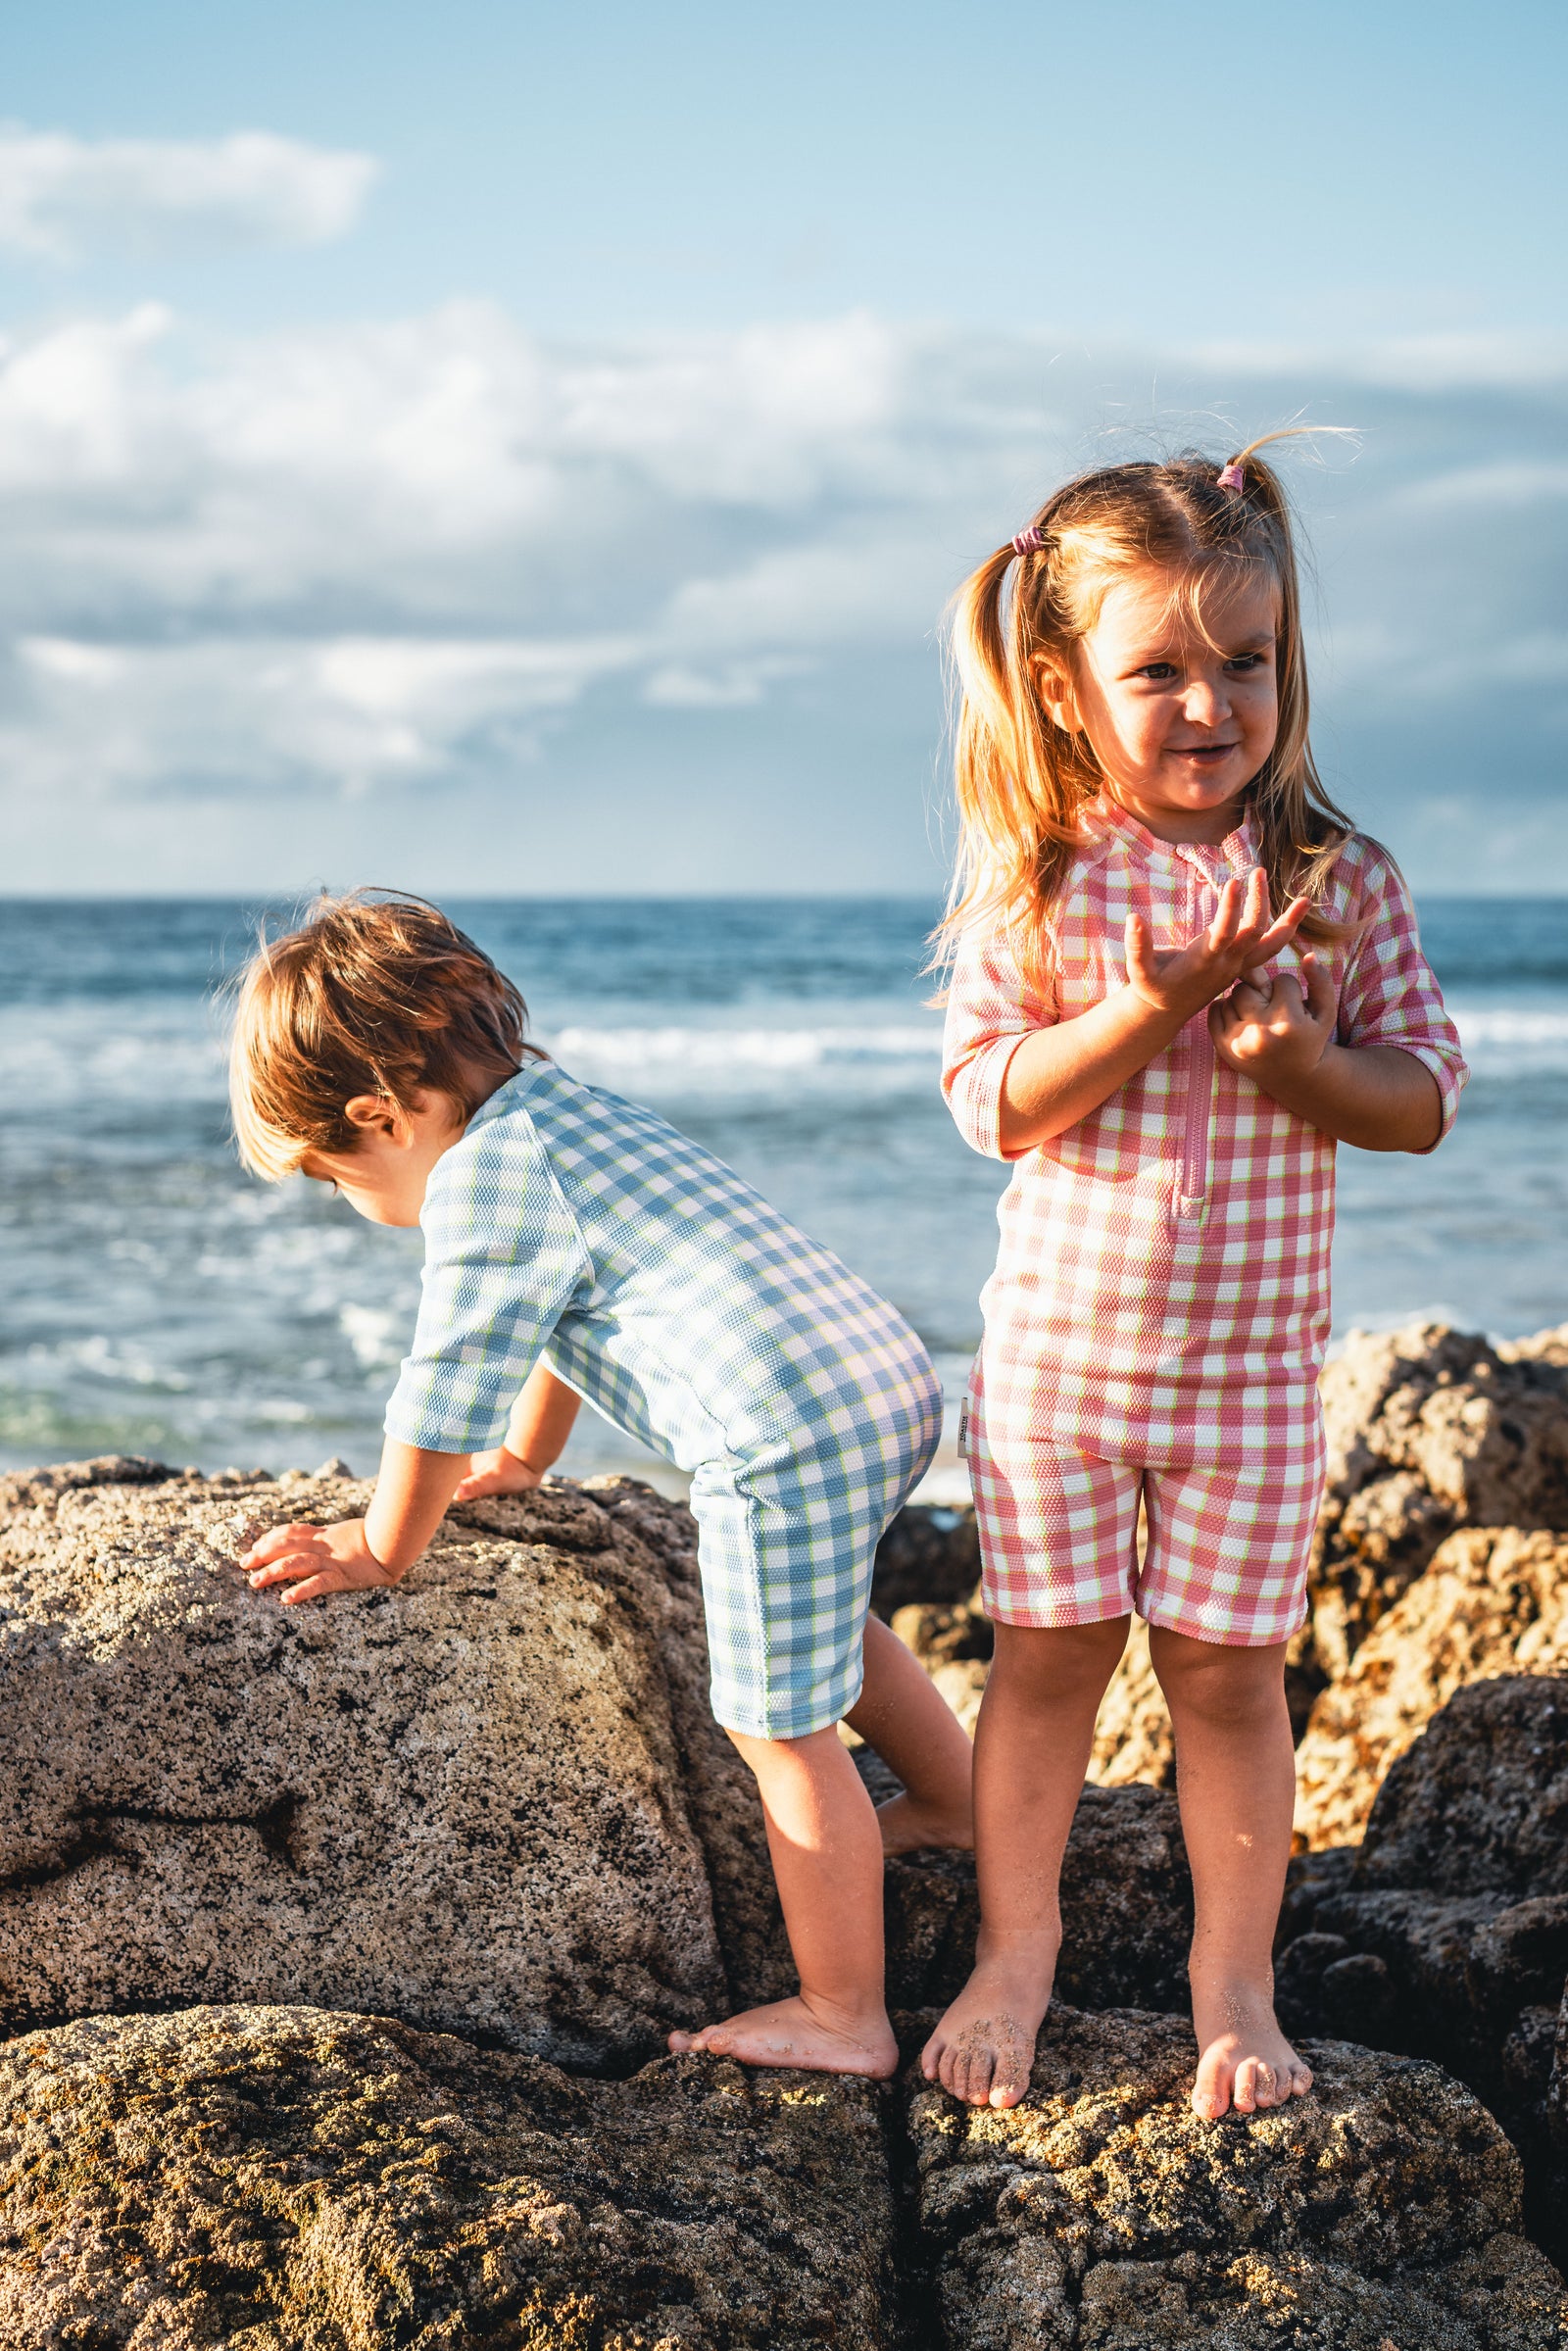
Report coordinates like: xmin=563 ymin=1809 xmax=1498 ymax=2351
xmin=0 ymin=127 xmax=378 ymax=261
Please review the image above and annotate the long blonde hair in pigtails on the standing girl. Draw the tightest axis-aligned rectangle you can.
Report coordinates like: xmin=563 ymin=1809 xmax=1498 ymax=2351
xmin=936 ymin=428 xmax=1351 ymax=976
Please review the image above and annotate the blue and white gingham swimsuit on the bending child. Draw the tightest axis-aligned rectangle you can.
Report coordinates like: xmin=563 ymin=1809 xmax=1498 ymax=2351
xmin=385 ymin=1060 xmax=943 ymax=1739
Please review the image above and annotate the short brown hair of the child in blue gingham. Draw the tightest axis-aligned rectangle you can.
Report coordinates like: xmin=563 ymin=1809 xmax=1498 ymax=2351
xmin=228 ymin=891 xmax=536 ymax=1183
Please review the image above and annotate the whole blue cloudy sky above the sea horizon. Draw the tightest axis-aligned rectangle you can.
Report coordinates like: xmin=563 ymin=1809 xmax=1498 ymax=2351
xmin=0 ymin=0 xmax=1568 ymax=894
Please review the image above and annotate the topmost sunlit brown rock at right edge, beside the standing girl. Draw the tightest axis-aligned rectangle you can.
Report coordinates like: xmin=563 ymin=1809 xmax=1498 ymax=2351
xmin=1293 ymin=1324 xmax=1568 ymax=1688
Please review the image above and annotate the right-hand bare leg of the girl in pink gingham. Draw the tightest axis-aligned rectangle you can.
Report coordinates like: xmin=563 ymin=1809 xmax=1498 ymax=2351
xmin=1150 ymin=1625 xmax=1312 ymax=2116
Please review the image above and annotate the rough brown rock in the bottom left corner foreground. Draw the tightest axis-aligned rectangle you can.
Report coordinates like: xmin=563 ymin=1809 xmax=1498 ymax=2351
xmin=0 ymin=2008 xmax=891 ymax=2351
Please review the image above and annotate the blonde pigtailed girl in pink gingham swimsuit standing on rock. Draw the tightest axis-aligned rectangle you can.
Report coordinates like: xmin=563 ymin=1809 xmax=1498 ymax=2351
xmin=924 ymin=435 xmax=1464 ymax=2116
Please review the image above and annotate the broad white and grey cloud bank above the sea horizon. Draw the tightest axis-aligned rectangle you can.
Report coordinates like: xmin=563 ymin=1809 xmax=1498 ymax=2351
xmin=0 ymin=303 xmax=1568 ymax=884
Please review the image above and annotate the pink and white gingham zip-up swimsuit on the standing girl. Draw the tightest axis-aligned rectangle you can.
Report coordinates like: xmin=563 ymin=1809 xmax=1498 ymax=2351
xmin=943 ymin=802 xmax=1467 ymax=1648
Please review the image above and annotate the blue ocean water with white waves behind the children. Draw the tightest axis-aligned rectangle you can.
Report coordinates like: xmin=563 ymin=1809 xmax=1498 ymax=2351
xmin=0 ymin=898 xmax=1568 ymax=1495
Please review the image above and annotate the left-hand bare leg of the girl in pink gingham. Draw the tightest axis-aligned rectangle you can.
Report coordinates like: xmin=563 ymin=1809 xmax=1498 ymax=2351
xmin=921 ymin=1618 xmax=1128 ymax=2107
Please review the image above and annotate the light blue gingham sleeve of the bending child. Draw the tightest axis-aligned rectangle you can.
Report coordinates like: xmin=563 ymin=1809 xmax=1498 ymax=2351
xmin=385 ymin=1112 xmax=590 ymax=1453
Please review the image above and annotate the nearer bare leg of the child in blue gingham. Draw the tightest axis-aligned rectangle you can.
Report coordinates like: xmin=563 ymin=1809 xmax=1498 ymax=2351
xmin=670 ymin=1731 xmax=898 ymax=2079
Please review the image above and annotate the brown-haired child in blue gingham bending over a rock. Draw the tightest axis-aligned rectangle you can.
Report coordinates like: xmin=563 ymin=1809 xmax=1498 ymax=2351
xmin=230 ymin=896 xmax=971 ymax=2076
